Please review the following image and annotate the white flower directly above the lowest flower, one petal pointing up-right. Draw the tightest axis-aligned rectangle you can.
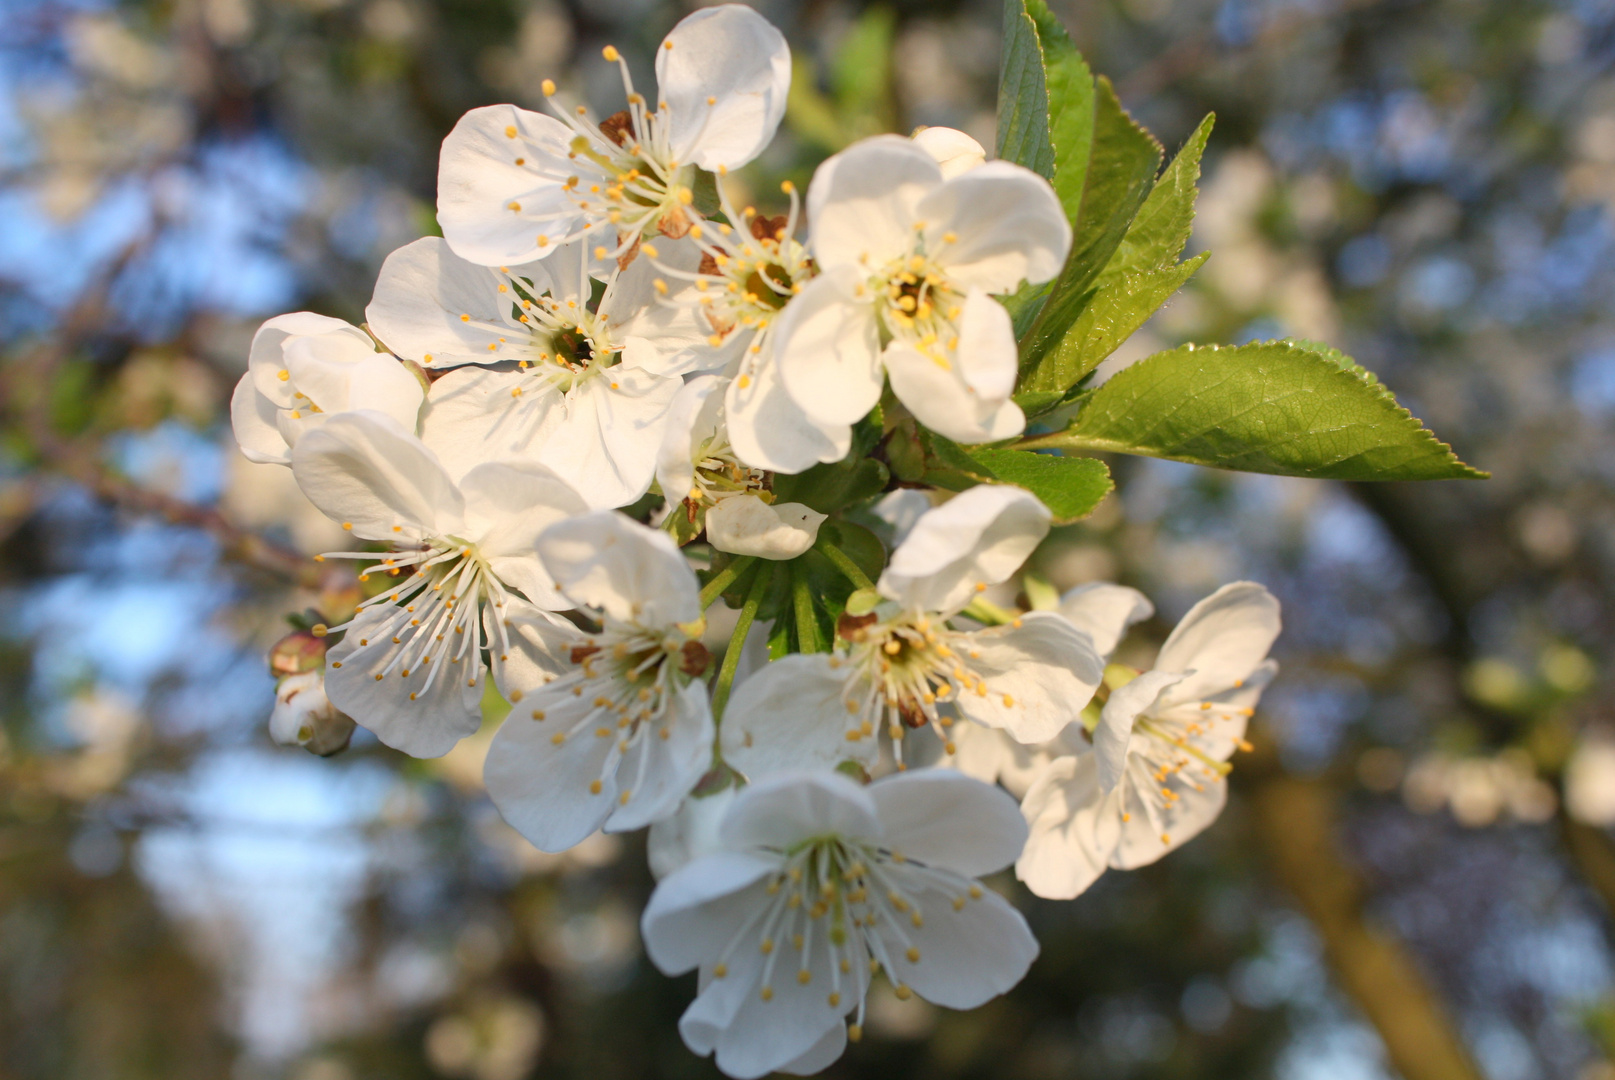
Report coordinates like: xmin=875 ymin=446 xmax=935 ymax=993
xmin=722 ymin=484 xmax=1103 ymax=773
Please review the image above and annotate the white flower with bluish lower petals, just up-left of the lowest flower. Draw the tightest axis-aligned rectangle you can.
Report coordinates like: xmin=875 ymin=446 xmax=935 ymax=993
xmin=483 ymin=510 xmax=712 ymax=851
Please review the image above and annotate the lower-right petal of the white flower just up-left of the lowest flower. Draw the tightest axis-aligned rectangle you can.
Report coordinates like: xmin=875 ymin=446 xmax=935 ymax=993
xmin=606 ymin=681 xmax=714 ymax=833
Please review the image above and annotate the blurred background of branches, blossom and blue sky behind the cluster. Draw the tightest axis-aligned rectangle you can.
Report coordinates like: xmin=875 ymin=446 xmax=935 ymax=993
xmin=0 ymin=0 xmax=1615 ymax=1080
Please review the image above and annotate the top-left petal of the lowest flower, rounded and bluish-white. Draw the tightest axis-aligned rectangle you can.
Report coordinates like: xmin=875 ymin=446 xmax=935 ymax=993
xmin=719 ymin=771 xmax=882 ymax=849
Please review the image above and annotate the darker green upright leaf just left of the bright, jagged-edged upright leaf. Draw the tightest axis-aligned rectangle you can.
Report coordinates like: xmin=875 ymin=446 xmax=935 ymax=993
xmin=1021 ymin=76 xmax=1163 ymax=391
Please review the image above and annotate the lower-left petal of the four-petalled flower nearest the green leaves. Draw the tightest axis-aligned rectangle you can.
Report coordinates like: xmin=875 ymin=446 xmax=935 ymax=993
xmin=774 ymin=273 xmax=885 ymax=425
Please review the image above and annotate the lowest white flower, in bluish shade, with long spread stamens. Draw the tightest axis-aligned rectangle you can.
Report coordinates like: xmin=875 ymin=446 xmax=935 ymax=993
xmin=641 ymin=770 xmax=1037 ymax=1080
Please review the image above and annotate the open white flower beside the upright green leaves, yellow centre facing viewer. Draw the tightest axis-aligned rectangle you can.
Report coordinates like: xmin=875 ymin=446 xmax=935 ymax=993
xmin=775 ymin=136 xmax=1071 ymax=442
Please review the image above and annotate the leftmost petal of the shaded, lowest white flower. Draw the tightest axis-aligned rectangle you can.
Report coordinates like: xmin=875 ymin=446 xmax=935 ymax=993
xmin=640 ymin=851 xmax=780 ymax=975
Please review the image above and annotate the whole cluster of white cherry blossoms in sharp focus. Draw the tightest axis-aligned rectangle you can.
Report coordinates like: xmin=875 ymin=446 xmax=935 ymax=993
xmin=231 ymin=5 xmax=1279 ymax=1077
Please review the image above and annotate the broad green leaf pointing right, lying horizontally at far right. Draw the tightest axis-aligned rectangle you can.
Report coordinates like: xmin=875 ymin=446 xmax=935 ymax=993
xmin=1021 ymin=341 xmax=1486 ymax=479
